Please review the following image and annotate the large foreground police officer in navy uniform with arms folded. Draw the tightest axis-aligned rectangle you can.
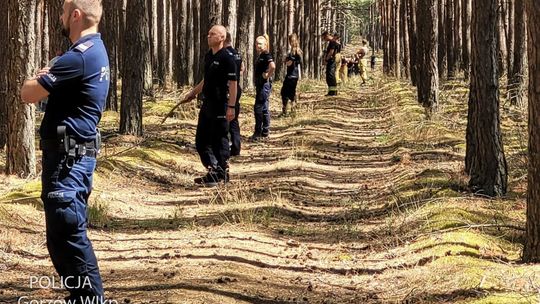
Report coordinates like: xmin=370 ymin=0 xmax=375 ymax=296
xmin=21 ymin=0 xmax=109 ymax=303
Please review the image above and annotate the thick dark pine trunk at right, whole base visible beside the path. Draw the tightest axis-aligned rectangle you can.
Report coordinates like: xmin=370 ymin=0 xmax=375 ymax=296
xmin=466 ymin=0 xmax=508 ymax=197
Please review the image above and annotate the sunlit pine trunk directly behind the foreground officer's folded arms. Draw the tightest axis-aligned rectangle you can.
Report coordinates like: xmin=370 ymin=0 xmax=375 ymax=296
xmin=6 ymin=0 xmax=36 ymax=177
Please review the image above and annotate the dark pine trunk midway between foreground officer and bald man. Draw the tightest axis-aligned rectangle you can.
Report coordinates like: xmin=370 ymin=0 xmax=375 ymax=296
xmin=120 ymin=0 xmax=150 ymax=136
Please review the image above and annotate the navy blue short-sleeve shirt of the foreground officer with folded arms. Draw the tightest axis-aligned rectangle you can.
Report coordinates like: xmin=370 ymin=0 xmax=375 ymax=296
xmin=37 ymin=33 xmax=110 ymax=141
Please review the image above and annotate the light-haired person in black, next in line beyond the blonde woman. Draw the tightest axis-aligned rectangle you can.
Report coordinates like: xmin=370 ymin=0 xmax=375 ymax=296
xmin=280 ymin=33 xmax=302 ymax=117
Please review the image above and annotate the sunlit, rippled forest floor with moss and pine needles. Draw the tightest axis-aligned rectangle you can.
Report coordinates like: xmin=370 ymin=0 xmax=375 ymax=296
xmin=0 ymin=70 xmax=540 ymax=304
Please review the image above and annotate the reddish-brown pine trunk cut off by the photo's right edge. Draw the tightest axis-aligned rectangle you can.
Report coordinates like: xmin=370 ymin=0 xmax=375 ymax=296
xmin=516 ymin=0 xmax=540 ymax=263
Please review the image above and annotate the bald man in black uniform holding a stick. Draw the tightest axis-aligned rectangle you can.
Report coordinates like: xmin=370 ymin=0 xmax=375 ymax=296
xmin=186 ymin=25 xmax=238 ymax=187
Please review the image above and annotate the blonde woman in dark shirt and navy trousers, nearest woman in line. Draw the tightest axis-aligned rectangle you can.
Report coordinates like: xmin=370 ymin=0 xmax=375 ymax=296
xmin=251 ymin=35 xmax=276 ymax=141
